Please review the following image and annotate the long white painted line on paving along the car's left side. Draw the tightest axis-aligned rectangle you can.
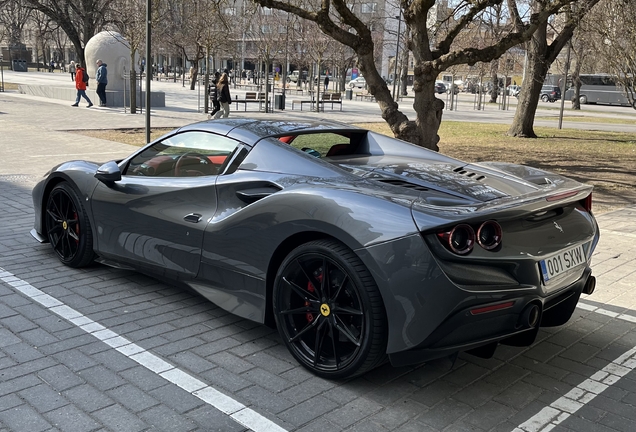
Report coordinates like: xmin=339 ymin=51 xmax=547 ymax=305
xmin=0 ymin=267 xmax=286 ymax=432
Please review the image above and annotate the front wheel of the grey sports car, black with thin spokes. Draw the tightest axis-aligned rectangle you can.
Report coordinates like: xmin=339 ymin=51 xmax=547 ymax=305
xmin=45 ymin=182 xmax=95 ymax=268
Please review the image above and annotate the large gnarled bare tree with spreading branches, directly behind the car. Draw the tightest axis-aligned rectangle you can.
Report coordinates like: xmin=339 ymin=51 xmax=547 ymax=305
xmin=254 ymin=0 xmax=592 ymax=150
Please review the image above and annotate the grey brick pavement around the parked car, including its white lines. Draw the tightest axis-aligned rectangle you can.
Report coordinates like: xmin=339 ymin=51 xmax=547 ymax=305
xmin=0 ymin=79 xmax=636 ymax=432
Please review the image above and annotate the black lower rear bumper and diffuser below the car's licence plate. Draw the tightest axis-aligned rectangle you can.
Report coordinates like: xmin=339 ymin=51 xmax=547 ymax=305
xmin=389 ymin=267 xmax=591 ymax=366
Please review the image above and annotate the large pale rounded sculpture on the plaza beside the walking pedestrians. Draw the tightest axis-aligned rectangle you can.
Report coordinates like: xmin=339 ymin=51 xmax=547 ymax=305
xmin=84 ymin=31 xmax=130 ymax=91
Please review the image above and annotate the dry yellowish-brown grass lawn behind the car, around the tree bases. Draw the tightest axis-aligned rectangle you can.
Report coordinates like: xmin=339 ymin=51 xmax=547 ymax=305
xmin=72 ymin=118 xmax=636 ymax=212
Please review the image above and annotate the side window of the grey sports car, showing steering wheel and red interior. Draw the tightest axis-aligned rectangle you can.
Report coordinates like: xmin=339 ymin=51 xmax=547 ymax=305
xmin=124 ymin=131 xmax=239 ymax=177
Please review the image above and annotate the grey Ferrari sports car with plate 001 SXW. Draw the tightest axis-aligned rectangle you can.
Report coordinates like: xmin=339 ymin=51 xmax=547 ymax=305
xmin=32 ymin=119 xmax=599 ymax=378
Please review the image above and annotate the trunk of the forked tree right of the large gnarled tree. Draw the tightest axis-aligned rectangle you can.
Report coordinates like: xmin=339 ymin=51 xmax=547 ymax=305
xmin=508 ymin=24 xmax=550 ymax=138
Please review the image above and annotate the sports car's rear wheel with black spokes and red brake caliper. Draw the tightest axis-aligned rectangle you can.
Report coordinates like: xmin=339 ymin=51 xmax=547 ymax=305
xmin=273 ymin=240 xmax=387 ymax=379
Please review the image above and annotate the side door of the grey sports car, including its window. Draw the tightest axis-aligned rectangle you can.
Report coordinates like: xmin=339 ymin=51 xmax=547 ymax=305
xmin=91 ymin=131 xmax=239 ymax=277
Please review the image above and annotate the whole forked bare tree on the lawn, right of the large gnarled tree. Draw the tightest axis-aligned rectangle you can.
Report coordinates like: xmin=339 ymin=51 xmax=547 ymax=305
xmin=508 ymin=0 xmax=599 ymax=138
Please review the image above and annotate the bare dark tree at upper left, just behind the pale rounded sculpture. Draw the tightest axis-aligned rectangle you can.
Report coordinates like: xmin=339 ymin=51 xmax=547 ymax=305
xmin=24 ymin=0 xmax=115 ymax=64
